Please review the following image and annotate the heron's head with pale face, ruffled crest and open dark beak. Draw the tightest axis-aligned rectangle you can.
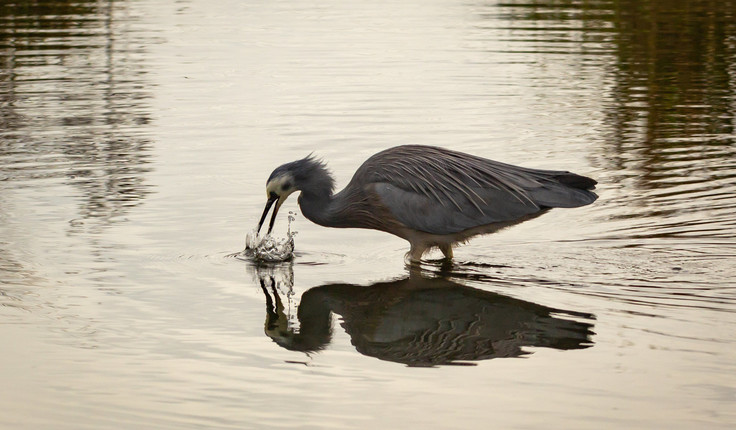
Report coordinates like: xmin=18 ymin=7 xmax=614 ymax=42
xmin=258 ymin=155 xmax=334 ymax=233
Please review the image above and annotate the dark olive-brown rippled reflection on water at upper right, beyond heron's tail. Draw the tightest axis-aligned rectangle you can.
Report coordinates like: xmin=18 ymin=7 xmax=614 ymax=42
xmin=499 ymin=0 xmax=736 ymax=242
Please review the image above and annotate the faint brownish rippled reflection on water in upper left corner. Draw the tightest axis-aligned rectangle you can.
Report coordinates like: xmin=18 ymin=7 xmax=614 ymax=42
xmin=0 ymin=1 xmax=151 ymax=227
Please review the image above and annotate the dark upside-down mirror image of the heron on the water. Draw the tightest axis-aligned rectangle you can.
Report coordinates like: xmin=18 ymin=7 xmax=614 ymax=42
xmin=261 ymin=275 xmax=594 ymax=366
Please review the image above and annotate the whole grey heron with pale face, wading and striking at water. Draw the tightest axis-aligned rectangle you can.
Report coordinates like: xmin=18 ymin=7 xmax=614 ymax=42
xmin=258 ymin=145 xmax=598 ymax=261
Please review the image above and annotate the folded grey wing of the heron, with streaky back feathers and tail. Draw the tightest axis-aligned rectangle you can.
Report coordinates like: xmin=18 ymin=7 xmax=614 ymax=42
xmin=356 ymin=145 xmax=597 ymax=234
